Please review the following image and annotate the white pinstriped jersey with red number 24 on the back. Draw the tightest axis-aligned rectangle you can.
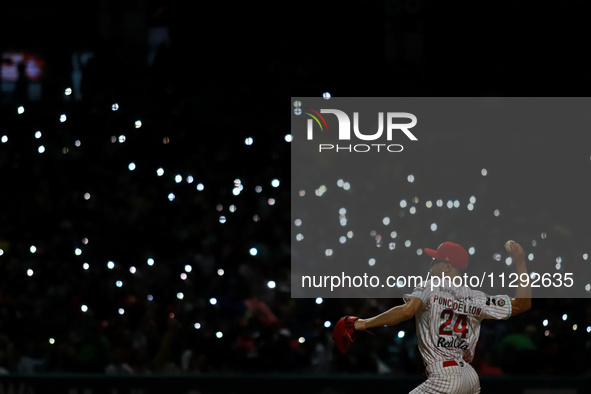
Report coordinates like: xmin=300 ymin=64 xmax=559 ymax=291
xmin=404 ymin=281 xmax=511 ymax=365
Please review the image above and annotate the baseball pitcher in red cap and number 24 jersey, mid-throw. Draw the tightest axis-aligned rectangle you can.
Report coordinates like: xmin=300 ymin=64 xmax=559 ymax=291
xmin=333 ymin=241 xmax=531 ymax=394
